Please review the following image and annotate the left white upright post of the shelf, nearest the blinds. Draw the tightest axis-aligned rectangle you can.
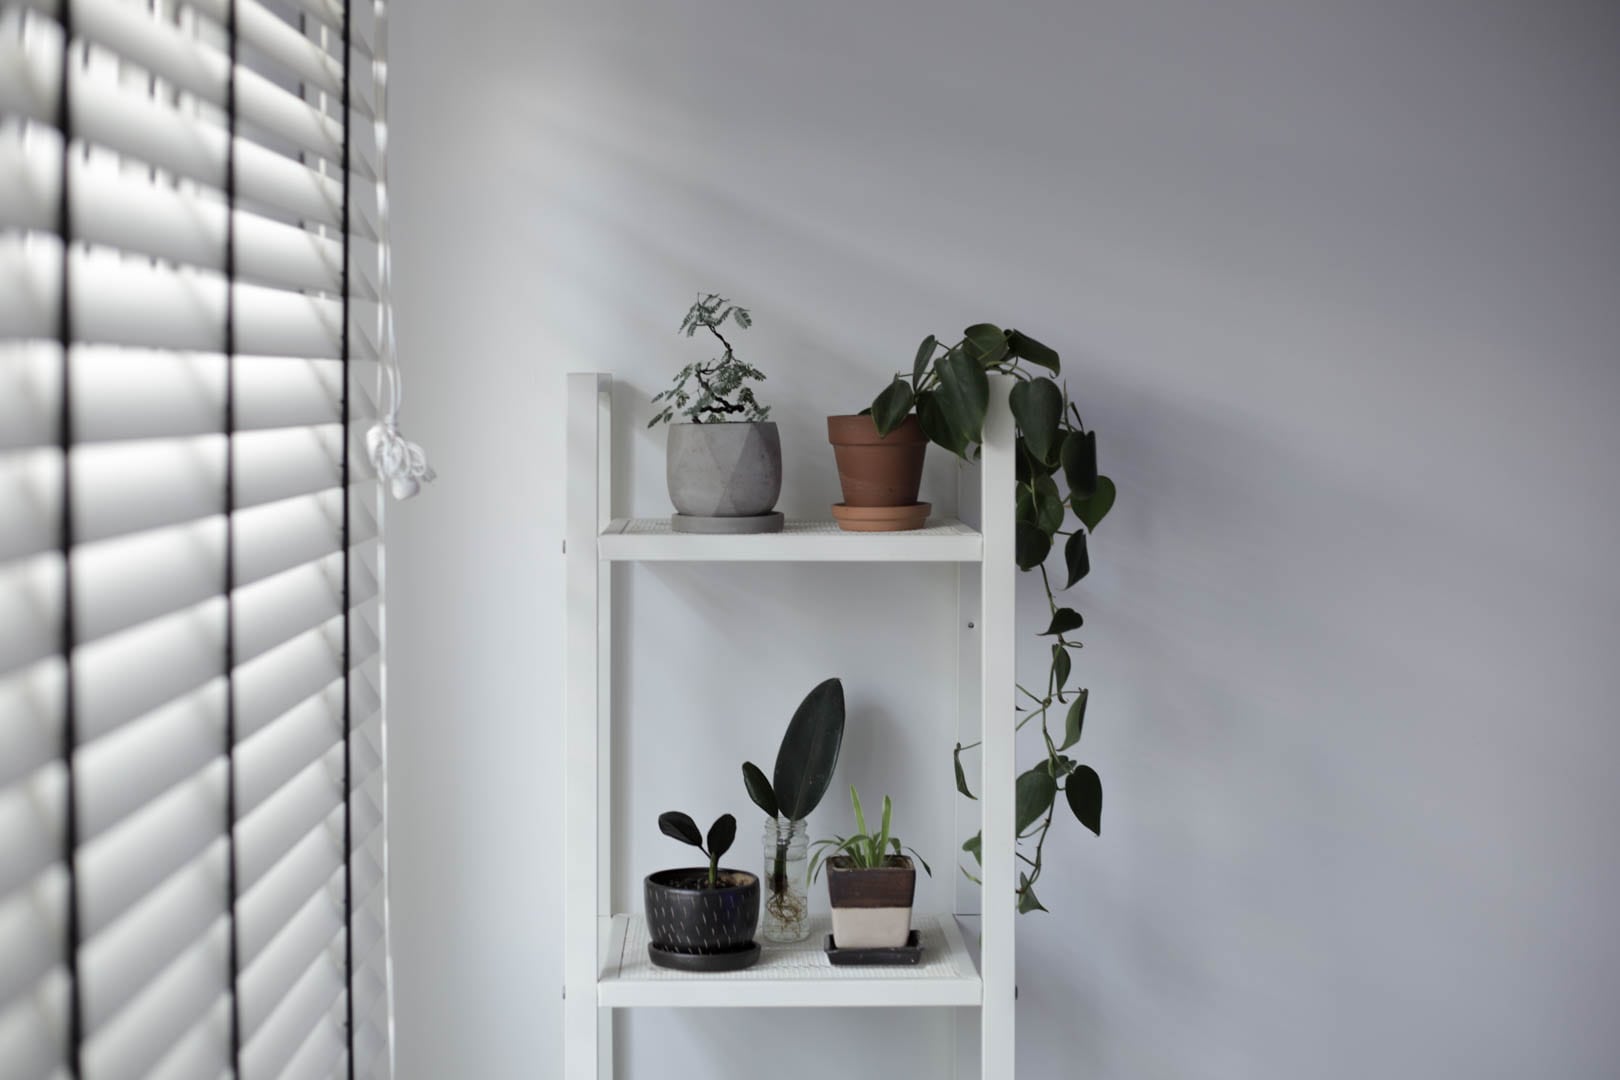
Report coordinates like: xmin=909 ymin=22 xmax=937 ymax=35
xmin=562 ymin=374 xmax=612 ymax=1080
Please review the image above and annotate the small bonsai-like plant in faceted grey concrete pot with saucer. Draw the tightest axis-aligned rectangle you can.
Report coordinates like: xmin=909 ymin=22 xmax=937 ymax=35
xmin=646 ymin=293 xmax=782 ymax=533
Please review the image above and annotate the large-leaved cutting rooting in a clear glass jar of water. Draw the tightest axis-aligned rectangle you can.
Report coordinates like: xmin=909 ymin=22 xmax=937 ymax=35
xmin=742 ymin=678 xmax=844 ymax=941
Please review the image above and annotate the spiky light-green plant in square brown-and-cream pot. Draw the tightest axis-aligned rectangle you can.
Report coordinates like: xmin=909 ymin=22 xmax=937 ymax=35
xmin=810 ymin=785 xmax=933 ymax=949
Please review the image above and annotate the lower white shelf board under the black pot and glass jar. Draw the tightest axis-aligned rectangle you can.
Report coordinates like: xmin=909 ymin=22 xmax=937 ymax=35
xmin=596 ymin=915 xmax=983 ymax=1009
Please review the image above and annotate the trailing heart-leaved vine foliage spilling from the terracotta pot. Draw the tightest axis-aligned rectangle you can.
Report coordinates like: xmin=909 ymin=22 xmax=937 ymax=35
xmin=870 ymin=322 xmax=1115 ymax=912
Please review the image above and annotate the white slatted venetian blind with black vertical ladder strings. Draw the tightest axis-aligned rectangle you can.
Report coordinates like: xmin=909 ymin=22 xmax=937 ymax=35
xmin=0 ymin=0 xmax=392 ymax=1078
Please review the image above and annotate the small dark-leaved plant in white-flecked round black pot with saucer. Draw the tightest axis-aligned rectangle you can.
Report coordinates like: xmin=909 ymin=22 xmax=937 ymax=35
xmin=643 ymin=810 xmax=760 ymax=972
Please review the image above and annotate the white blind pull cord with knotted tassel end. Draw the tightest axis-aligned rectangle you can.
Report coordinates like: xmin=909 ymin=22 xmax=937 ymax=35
xmin=366 ymin=0 xmax=437 ymax=499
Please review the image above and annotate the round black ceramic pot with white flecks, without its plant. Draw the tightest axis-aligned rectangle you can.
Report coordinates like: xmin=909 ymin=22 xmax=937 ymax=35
xmin=646 ymin=866 xmax=760 ymax=955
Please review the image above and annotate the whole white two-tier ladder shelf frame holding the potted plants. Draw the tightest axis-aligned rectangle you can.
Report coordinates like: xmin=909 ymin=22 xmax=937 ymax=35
xmin=564 ymin=372 xmax=1017 ymax=1080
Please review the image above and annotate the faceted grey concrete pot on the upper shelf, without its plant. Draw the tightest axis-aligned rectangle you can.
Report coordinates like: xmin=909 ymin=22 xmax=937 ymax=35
xmin=666 ymin=421 xmax=782 ymax=518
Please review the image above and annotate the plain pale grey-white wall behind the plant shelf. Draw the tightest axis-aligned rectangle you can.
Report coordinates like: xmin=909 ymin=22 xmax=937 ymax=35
xmin=389 ymin=0 xmax=1620 ymax=1080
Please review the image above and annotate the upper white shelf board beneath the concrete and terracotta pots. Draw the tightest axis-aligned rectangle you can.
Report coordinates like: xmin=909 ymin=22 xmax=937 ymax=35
xmin=596 ymin=518 xmax=985 ymax=562
